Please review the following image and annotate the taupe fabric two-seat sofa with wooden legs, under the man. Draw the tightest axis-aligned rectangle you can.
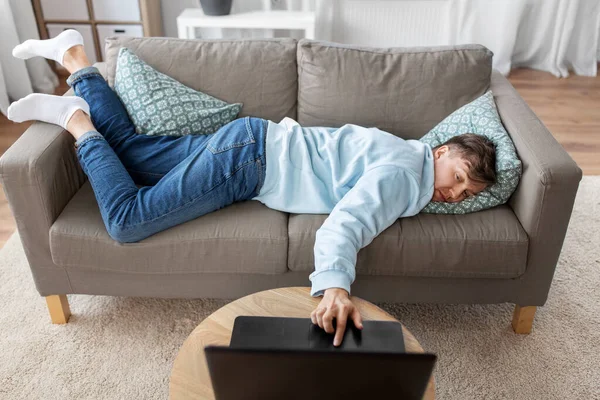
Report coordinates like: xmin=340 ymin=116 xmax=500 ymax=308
xmin=0 ymin=38 xmax=582 ymax=333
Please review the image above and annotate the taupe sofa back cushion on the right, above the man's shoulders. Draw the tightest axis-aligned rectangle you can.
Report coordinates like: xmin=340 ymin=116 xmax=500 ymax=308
xmin=297 ymin=39 xmax=493 ymax=139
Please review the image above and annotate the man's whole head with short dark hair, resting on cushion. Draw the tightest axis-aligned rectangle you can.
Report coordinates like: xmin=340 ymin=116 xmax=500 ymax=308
xmin=431 ymin=133 xmax=496 ymax=203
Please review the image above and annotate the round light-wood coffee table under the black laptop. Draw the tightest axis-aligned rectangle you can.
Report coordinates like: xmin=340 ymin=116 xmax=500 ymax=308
xmin=169 ymin=287 xmax=435 ymax=400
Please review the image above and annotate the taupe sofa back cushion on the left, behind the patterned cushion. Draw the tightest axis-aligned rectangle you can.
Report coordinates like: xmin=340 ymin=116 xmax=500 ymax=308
xmin=106 ymin=36 xmax=298 ymax=121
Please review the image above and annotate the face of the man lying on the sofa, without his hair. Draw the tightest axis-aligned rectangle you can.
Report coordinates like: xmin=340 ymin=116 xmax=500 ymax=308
xmin=431 ymin=146 xmax=486 ymax=203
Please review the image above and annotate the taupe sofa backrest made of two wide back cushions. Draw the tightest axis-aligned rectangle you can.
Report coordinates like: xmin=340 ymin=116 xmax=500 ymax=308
xmin=106 ymin=37 xmax=493 ymax=139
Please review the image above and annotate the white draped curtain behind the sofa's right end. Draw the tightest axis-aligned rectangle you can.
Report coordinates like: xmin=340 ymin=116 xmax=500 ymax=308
xmin=449 ymin=0 xmax=600 ymax=77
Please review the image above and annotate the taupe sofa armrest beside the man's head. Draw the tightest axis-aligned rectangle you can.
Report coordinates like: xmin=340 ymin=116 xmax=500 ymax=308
xmin=491 ymin=70 xmax=582 ymax=305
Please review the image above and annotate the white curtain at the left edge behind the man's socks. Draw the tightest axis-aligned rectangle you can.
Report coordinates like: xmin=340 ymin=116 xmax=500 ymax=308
xmin=0 ymin=0 xmax=58 ymax=115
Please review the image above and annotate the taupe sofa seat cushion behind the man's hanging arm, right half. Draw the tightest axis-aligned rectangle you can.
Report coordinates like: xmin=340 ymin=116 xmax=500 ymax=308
xmin=288 ymin=205 xmax=529 ymax=279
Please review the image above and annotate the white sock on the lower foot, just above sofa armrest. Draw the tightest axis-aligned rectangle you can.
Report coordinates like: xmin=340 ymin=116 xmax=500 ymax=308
xmin=8 ymin=93 xmax=90 ymax=129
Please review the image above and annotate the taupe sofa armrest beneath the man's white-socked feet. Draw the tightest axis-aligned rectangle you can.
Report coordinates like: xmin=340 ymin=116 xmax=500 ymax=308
xmin=0 ymin=63 xmax=106 ymax=293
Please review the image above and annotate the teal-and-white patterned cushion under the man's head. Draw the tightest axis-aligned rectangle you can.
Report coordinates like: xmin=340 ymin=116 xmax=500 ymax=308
xmin=420 ymin=91 xmax=521 ymax=214
